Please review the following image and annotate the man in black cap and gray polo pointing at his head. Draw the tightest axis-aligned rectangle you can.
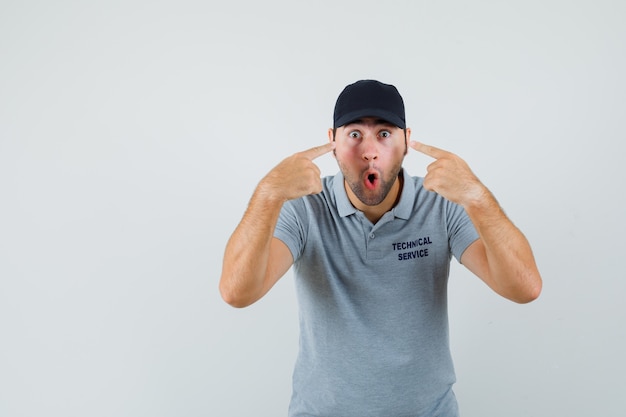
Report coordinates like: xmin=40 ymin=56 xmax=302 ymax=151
xmin=220 ymin=80 xmax=541 ymax=417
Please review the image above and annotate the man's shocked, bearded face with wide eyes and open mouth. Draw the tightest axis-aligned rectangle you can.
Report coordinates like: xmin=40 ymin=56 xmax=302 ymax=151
xmin=329 ymin=118 xmax=410 ymax=206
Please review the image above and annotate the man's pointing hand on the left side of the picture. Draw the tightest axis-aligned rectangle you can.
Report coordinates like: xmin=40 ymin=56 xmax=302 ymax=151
xmin=259 ymin=142 xmax=335 ymax=202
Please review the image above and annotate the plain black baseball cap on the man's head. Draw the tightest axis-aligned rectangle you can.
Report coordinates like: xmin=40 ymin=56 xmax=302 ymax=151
xmin=333 ymin=80 xmax=406 ymax=129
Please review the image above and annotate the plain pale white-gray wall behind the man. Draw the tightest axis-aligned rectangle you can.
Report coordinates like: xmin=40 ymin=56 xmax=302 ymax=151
xmin=0 ymin=0 xmax=626 ymax=417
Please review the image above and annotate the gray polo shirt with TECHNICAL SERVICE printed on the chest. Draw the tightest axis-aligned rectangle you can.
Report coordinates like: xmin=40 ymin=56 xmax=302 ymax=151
xmin=275 ymin=167 xmax=478 ymax=417
